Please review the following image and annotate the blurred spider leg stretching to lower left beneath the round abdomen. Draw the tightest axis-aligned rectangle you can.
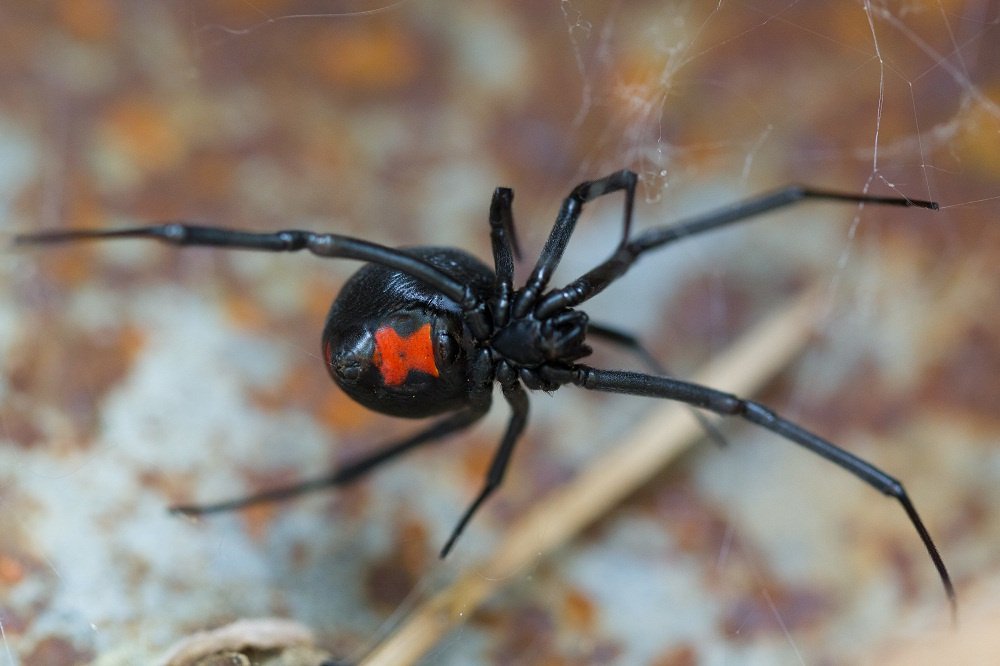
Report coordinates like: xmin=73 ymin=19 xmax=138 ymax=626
xmin=169 ymin=402 xmax=490 ymax=516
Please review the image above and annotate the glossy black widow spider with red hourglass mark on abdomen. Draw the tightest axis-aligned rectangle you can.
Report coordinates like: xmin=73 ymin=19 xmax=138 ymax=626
xmin=14 ymin=170 xmax=955 ymax=613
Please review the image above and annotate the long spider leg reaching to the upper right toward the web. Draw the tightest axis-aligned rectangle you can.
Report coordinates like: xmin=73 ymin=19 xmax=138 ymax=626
xmin=535 ymin=180 xmax=938 ymax=318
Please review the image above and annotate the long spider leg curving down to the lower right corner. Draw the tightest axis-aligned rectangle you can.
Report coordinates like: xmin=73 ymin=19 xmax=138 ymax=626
xmin=565 ymin=365 xmax=957 ymax=618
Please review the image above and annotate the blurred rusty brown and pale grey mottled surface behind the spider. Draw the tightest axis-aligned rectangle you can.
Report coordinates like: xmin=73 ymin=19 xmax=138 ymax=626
xmin=0 ymin=0 xmax=1000 ymax=666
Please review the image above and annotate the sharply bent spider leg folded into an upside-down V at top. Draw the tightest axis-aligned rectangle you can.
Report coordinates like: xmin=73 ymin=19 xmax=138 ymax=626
xmin=514 ymin=169 xmax=638 ymax=317
